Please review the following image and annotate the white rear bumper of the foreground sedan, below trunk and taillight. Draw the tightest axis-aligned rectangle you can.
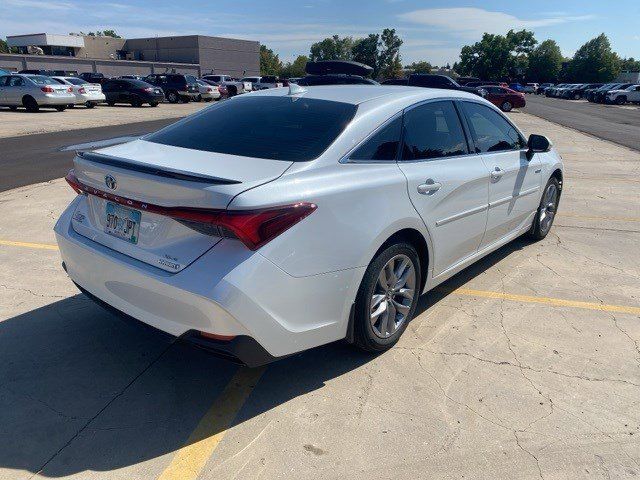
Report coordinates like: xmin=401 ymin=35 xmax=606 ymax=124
xmin=55 ymin=201 xmax=364 ymax=365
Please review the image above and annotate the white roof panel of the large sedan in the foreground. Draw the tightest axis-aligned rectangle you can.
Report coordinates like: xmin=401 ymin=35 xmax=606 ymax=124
xmin=251 ymin=85 xmax=481 ymax=105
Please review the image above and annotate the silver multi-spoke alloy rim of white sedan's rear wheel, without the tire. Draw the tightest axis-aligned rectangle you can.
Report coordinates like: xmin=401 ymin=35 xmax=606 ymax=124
xmin=369 ymin=254 xmax=416 ymax=338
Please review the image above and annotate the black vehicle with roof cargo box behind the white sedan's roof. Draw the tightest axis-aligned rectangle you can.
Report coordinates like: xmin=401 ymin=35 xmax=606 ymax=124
xmin=296 ymin=60 xmax=378 ymax=87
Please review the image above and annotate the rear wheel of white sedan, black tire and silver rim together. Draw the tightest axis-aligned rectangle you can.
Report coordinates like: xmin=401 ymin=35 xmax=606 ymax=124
xmin=353 ymin=242 xmax=422 ymax=352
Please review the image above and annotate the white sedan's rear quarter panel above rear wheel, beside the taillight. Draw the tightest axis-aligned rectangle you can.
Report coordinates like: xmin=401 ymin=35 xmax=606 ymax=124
xmin=231 ymin=162 xmax=431 ymax=277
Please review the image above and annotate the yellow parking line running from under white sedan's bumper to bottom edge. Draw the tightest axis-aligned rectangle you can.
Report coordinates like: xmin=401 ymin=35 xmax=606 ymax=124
xmin=158 ymin=367 xmax=265 ymax=480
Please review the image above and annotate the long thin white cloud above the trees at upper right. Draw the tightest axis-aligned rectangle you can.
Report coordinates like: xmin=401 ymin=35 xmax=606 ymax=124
xmin=398 ymin=7 xmax=595 ymax=38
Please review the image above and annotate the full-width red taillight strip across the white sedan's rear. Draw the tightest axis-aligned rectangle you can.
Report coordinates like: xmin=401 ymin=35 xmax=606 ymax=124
xmin=66 ymin=170 xmax=318 ymax=250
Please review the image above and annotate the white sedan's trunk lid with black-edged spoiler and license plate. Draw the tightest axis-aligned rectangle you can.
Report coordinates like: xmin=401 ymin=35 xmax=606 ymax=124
xmin=72 ymin=140 xmax=291 ymax=272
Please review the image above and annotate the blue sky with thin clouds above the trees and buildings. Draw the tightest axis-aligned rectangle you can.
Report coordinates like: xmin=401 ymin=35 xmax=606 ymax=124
xmin=0 ymin=0 xmax=640 ymax=66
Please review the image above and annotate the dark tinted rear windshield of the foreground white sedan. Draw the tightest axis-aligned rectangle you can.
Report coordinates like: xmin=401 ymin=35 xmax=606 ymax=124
xmin=144 ymin=95 xmax=357 ymax=162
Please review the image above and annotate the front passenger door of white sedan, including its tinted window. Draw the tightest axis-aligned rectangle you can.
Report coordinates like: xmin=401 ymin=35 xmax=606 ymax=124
xmin=460 ymin=101 xmax=542 ymax=249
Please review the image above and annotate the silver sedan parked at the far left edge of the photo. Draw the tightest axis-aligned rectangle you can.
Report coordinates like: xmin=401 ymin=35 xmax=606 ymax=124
xmin=0 ymin=74 xmax=76 ymax=112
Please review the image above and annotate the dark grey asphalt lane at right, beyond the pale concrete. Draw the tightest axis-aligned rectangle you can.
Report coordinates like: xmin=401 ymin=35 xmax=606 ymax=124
xmin=523 ymin=95 xmax=640 ymax=150
